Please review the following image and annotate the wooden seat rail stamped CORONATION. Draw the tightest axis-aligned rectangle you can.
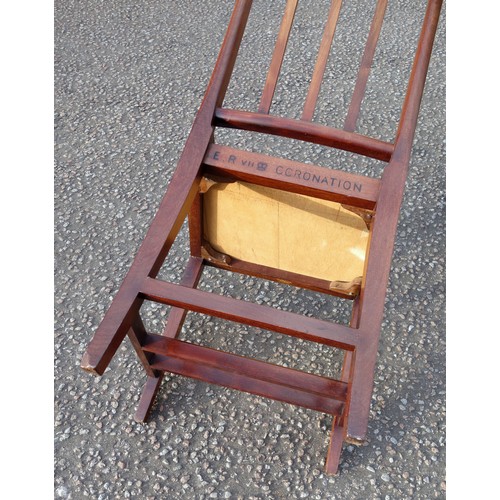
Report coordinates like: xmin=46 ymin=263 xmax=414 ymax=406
xmin=203 ymin=144 xmax=380 ymax=210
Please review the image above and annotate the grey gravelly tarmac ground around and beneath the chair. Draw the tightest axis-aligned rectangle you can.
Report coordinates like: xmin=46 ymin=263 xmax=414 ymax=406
xmin=54 ymin=0 xmax=446 ymax=500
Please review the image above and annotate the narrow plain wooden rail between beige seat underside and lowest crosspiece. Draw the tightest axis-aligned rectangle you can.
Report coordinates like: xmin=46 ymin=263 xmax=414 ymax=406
xmin=140 ymin=278 xmax=359 ymax=351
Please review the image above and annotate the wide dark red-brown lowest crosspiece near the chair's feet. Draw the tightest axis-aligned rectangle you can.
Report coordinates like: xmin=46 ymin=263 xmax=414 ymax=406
xmin=143 ymin=334 xmax=347 ymax=415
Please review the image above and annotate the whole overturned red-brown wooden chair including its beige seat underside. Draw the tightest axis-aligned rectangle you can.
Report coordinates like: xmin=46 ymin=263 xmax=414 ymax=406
xmin=81 ymin=0 xmax=441 ymax=473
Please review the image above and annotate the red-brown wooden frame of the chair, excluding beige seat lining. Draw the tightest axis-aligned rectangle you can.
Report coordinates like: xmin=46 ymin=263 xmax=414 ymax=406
xmin=81 ymin=0 xmax=442 ymax=474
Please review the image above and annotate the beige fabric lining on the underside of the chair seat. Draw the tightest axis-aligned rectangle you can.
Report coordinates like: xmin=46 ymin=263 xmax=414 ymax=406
xmin=203 ymin=182 xmax=369 ymax=282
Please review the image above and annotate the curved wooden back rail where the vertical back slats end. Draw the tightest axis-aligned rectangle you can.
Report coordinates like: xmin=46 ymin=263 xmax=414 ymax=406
xmin=214 ymin=108 xmax=394 ymax=162
